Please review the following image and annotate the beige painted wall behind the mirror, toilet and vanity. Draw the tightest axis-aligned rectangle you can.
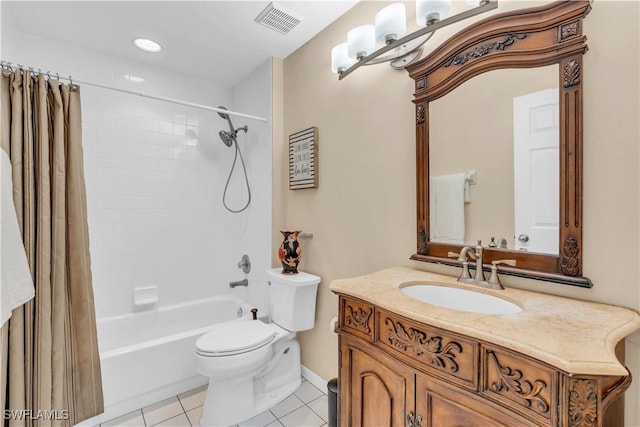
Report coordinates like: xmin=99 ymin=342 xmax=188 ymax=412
xmin=273 ymin=0 xmax=640 ymax=426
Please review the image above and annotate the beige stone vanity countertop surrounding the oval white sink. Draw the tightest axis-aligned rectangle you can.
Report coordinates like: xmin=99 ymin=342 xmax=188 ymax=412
xmin=330 ymin=267 xmax=640 ymax=376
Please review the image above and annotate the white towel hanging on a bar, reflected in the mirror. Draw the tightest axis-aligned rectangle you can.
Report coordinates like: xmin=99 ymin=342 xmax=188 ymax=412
xmin=429 ymin=173 xmax=466 ymax=243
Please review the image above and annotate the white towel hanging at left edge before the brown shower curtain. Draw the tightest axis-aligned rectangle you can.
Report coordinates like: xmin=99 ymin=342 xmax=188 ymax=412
xmin=0 ymin=149 xmax=35 ymax=326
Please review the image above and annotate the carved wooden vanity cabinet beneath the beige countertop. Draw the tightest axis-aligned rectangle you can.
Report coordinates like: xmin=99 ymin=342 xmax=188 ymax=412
xmin=336 ymin=295 xmax=630 ymax=427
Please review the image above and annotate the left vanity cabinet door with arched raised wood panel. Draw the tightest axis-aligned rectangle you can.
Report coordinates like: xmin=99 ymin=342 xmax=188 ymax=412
xmin=340 ymin=338 xmax=415 ymax=427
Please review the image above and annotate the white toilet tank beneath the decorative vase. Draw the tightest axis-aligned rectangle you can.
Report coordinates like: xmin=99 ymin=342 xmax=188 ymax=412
xmin=267 ymin=268 xmax=320 ymax=332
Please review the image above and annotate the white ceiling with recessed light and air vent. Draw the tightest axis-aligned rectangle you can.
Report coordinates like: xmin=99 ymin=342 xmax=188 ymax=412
xmin=2 ymin=0 xmax=357 ymax=86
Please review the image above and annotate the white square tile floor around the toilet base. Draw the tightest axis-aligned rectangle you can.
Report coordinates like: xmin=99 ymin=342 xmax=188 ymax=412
xmin=100 ymin=378 xmax=328 ymax=427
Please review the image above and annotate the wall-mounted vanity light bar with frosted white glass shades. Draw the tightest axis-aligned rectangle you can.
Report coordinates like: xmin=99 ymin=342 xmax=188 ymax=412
xmin=331 ymin=0 xmax=498 ymax=80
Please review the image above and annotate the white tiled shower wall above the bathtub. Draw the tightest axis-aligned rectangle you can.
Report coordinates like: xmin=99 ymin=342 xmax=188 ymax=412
xmin=2 ymin=15 xmax=271 ymax=319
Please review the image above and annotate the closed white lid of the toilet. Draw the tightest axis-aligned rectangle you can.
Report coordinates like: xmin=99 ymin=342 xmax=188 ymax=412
xmin=196 ymin=320 xmax=276 ymax=356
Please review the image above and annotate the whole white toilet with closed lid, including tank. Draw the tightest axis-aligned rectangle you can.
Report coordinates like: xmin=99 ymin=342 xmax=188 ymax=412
xmin=195 ymin=268 xmax=320 ymax=426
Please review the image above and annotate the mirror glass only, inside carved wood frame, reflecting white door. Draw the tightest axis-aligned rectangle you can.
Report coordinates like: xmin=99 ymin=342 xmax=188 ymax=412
xmin=429 ymin=64 xmax=559 ymax=254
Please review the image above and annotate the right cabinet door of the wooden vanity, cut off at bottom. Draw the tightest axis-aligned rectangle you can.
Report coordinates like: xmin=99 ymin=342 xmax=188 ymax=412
xmin=416 ymin=375 xmax=534 ymax=427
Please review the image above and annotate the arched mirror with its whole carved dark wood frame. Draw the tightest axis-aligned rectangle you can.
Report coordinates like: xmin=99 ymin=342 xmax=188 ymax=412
xmin=407 ymin=1 xmax=592 ymax=287
